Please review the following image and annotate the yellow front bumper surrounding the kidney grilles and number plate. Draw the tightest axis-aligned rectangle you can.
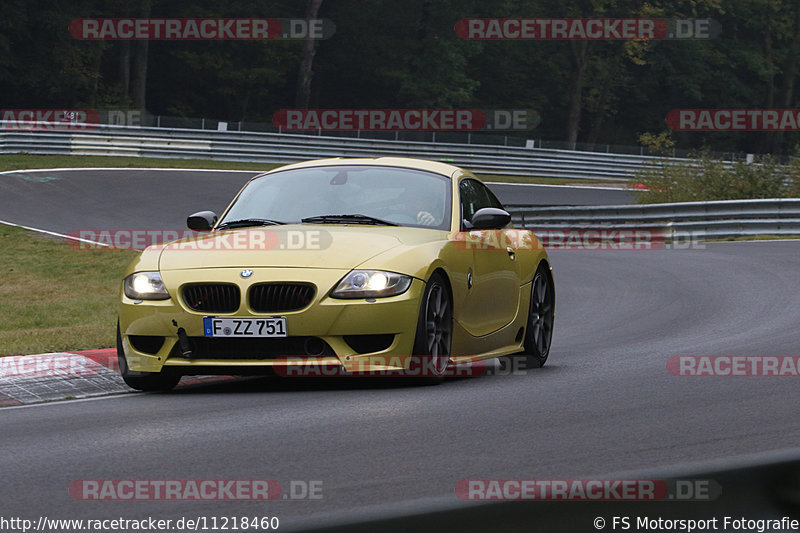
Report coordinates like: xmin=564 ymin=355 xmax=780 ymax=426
xmin=119 ymin=268 xmax=425 ymax=375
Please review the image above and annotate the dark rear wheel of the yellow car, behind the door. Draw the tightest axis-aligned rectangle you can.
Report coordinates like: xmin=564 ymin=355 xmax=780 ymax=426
xmin=522 ymin=263 xmax=555 ymax=368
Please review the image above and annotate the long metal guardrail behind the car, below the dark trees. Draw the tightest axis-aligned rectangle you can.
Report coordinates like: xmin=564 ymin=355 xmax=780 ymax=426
xmin=0 ymin=121 xmax=690 ymax=181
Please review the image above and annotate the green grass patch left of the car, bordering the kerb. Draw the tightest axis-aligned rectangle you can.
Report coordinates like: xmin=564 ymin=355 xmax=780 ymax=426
xmin=0 ymin=225 xmax=137 ymax=356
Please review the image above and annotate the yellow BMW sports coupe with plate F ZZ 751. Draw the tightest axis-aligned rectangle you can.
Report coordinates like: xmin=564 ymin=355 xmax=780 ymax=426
xmin=117 ymin=158 xmax=555 ymax=390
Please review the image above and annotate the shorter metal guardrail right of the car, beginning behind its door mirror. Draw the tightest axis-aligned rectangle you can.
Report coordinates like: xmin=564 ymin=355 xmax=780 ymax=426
xmin=506 ymin=198 xmax=800 ymax=240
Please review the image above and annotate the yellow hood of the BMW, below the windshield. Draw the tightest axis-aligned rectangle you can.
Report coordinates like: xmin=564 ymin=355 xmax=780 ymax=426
xmin=159 ymin=224 xmax=446 ymax=270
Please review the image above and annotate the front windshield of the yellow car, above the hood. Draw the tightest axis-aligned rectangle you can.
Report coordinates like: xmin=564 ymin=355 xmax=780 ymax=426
xmin=220 ymin=165 xmax=451 ymax=230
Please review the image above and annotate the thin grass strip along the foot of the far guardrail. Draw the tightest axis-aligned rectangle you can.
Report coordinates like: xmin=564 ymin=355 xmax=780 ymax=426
xmin=0 ymin=154 xmax=603 ymax=185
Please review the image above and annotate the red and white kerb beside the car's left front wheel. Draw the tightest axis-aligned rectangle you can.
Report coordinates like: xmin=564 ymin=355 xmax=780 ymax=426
xmin=0 ymin=348 xmax=231 ymax=407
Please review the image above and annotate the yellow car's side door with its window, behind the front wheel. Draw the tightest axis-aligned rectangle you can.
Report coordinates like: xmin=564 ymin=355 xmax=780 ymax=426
xmin=459 ymin=178 xmax=520 ymax=336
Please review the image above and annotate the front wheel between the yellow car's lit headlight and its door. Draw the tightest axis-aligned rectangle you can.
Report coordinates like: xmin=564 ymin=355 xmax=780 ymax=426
xmin=412 ymin=272 xmax=453 ymax=385
